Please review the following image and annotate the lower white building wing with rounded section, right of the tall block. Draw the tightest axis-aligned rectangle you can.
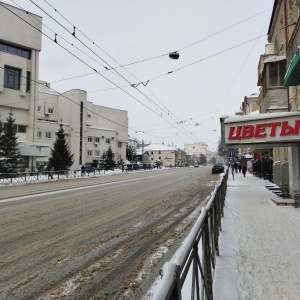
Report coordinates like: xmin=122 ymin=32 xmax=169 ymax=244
xmin=36 ymin=84 xmax=128 ymax=167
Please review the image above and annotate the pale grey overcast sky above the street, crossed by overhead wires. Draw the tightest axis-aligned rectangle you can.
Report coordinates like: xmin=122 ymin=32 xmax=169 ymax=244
xmin=1 ymin=0 xmax=274 ymax=150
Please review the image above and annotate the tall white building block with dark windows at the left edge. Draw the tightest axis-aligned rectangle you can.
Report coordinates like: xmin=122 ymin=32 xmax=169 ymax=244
xmin=0 ymin=2 xmax=50 ymax=167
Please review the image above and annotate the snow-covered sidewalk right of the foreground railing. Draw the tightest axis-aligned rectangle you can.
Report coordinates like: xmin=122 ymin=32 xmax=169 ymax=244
xmin=214 ymin=173 xmax=300 ymax=300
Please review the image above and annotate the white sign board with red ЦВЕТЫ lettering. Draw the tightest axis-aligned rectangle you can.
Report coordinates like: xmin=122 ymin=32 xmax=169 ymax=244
xmin=224 ymin=113 xmax=300 ymax=145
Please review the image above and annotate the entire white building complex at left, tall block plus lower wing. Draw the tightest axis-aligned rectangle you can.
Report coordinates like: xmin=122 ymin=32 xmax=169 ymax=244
xmin=0 ymin=2 xmax=128 ymax=168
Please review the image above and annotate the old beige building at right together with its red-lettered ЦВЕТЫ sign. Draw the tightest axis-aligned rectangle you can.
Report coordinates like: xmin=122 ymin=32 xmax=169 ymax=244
xmin=221 ymin=0 xmax=300 ymax=197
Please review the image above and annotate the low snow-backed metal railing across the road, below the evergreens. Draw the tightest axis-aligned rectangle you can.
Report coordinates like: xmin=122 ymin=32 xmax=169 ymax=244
xmin=0 ymin=169 xmax=105 ymax=185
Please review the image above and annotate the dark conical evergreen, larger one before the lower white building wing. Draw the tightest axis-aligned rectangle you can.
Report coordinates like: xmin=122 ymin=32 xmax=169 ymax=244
xmin=48 ymin=124 xmax=74 ymax=171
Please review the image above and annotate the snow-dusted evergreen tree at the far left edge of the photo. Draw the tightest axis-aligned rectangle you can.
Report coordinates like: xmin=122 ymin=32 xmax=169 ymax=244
xmin=0 ymin=111 xmax=24 ymax=173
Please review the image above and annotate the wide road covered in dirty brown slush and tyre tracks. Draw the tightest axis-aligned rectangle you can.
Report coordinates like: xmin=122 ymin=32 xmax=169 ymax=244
xmin=0 ymin=166 xmax=219 ymax=300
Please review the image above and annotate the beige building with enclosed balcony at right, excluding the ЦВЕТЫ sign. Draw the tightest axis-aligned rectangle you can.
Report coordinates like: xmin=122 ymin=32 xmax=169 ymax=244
xmin=257 ymin=0 xmax=300 ymax=195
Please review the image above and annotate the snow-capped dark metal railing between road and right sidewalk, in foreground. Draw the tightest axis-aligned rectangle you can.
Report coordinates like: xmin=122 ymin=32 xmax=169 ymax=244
xmin=152 ymin=168 xmax=228 ymax=300
